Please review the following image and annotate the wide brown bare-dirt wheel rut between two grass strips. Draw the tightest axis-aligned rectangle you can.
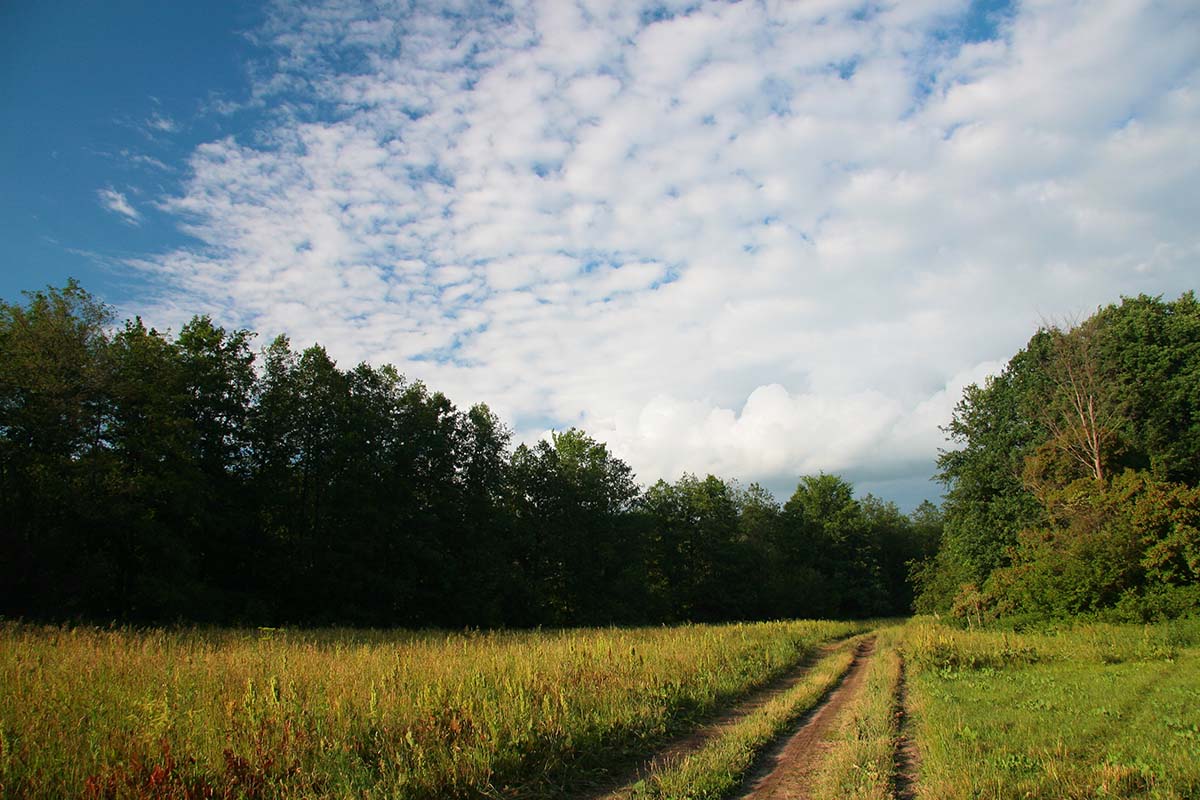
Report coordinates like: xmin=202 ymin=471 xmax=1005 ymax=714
xmin=739 ymin=637 xmax=875 ymax=800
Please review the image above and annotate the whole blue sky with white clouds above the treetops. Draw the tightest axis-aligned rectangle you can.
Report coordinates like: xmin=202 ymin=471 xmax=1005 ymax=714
xmin=0 ymin=0 xmax=1200 ymax=509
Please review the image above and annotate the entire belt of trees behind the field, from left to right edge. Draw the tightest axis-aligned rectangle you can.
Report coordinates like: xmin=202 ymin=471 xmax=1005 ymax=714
xmin=0 ymin=282 xmax=1200 ymax=627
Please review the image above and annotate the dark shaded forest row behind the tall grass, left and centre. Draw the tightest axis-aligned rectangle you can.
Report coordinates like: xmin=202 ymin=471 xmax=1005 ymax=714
xmin=0 ymin=282 xmax=936 ymax=626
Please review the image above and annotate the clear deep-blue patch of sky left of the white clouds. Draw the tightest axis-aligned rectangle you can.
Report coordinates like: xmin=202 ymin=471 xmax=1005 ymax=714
xmin=0 ymin=0 xmax=263 ymax=301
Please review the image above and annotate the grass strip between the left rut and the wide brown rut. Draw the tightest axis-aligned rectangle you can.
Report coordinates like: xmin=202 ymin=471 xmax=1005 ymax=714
xmin=634 ymin=636 xmax=864 ymax=800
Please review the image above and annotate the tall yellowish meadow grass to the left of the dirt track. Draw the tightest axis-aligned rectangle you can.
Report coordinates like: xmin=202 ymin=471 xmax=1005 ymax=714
xmin=0 ymin=622 xmax=863 ymax=799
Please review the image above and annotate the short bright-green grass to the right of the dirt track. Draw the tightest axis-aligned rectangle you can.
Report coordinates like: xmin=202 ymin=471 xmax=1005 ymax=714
xmin=906 ymin=622 xmax=1200 ymax=799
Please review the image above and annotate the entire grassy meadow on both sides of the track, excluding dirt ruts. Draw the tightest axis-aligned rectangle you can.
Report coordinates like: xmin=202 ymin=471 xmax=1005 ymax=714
xmin=0 ymin=619 xmax=1200 ymax=800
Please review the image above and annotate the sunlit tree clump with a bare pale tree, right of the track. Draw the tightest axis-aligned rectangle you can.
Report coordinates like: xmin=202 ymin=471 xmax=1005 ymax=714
xmin=914 ymin=291 xmax=1200 ymax=622
